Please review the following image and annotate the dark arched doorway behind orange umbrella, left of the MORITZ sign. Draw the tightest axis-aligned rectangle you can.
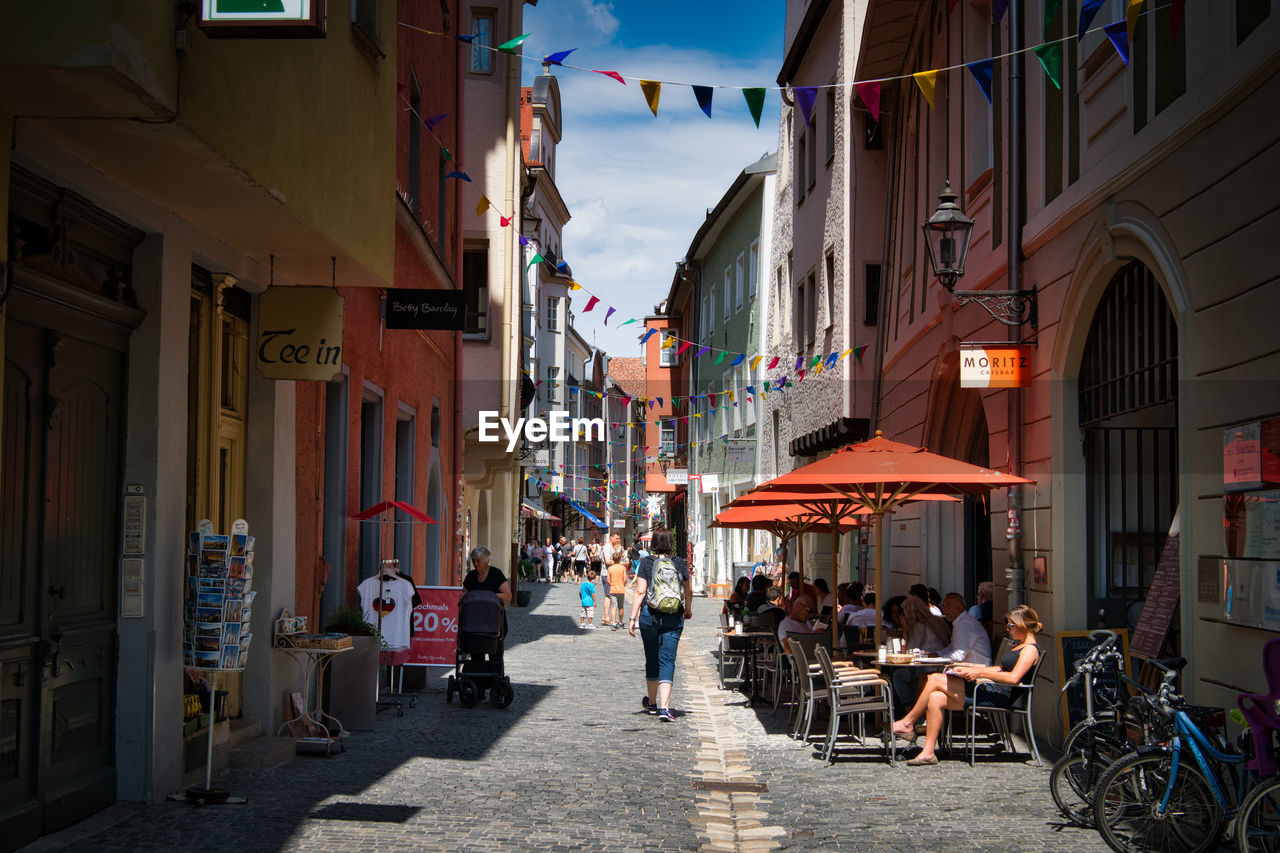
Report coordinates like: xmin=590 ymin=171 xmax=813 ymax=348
xmin=922 ymin=350 xmax=992 ymax=603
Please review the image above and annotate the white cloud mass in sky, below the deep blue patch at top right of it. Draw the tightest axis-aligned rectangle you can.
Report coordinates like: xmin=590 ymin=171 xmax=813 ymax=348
xmin=527 ymin=13 xmax=778 ymax=356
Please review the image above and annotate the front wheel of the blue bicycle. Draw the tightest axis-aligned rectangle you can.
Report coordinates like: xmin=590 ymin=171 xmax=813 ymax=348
xmin=1093 ymin=753 xmax=1224 ymax=853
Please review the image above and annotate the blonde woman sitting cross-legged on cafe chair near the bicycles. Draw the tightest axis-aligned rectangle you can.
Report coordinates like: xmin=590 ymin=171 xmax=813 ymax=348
xmin=893 ymin=605 xmax=1042 ymax=767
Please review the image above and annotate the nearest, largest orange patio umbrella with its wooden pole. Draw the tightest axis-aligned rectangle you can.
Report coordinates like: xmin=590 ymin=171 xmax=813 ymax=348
xmin=751 ymin=430 xmax=1030 ymax=646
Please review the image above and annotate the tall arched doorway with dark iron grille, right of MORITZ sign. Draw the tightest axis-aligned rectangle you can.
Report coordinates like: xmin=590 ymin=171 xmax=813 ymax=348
xmin=1078 ymin=261 xmax=1178 ymax=629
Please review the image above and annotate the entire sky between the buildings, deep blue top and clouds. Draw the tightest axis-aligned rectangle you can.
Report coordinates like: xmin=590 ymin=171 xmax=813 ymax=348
xmin=524 ymin=0 xmax=785 ymax=356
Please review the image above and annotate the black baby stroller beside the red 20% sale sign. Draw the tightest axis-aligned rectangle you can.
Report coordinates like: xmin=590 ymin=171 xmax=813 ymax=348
xmin=444 ymin=589 xmax=516 ymax=708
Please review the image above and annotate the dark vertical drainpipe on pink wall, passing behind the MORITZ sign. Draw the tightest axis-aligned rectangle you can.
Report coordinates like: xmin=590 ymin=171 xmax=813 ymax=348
xmin=1005 ymin=3 xmax=1027 ymax=607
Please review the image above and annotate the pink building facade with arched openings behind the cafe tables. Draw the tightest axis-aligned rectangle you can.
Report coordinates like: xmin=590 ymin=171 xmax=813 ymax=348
xmin=798 ymin=0 xmax=1280 ymax=739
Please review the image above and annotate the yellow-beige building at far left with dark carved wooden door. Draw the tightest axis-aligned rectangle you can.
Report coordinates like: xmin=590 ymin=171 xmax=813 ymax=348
xmin=0 ymin=4 xmax=398 ymax=844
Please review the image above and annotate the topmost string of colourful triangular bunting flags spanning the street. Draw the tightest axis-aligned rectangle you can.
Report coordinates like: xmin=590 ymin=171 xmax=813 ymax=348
xmin=397 ymin=0 xmax=1187 ymax=124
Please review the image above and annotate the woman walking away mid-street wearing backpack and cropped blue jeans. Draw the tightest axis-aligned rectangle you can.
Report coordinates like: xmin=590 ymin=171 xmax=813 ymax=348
xmin=628 ymin=528 xmax=694 ymax=722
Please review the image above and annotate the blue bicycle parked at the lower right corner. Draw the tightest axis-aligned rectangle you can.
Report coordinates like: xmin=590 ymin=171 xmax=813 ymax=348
xmin=1093 ymin=663 xmax=1257 ymax=853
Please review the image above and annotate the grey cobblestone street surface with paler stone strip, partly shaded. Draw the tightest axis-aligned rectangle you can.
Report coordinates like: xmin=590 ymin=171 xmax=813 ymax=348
xmin=40 ymin=584 xmax=1105 ymax=853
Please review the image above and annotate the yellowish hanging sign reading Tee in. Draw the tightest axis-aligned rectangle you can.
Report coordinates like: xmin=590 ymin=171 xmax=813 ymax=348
xmin=257 ymin=287 xmax=343 ymax=382
